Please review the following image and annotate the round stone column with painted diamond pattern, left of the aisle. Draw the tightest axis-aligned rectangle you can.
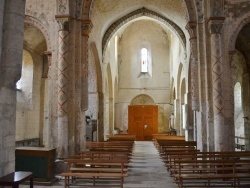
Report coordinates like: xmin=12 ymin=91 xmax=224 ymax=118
xmin=57 ymin=17 xmax=69 ymax=158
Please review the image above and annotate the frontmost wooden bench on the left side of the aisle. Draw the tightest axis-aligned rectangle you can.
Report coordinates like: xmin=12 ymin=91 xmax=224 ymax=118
xmin=60 ymin=159 xmax=128 ymax=188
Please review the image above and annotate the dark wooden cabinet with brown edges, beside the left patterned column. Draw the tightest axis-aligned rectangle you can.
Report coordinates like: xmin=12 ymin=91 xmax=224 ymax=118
xmin=15 ymin=147 xmax=56 ymax=181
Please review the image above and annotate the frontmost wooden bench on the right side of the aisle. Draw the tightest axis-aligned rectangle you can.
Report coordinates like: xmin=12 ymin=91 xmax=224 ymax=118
xmin=173 ymin=159 xmax=250 ymax=187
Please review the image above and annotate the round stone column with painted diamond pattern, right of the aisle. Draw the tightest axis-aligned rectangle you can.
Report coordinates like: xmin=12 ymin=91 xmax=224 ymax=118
xmin=209 ymin=18 xmax=231 ymax=151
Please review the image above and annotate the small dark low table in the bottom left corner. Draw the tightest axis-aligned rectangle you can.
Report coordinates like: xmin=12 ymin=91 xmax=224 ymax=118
xmin=0 ymin=171 xmax=33 ymax=188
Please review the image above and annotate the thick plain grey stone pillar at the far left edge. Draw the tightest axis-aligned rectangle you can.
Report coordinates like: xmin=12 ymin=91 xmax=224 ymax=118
xmin=0 ymin=0 xmax=25 ymax=176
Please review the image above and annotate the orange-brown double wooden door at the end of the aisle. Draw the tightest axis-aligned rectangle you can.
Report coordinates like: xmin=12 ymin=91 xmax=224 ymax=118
xmin=128 ymin=105 xmax=158 ymax=141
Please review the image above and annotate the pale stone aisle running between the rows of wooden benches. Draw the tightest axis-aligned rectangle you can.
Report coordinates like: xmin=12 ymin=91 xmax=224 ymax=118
xmin=124 ymin=141 xmax=178 ymax=188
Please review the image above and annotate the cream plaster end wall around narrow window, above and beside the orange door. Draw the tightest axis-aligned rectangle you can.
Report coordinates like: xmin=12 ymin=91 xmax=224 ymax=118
xmin=115 ymin=20 xmax=176 ymax=132
